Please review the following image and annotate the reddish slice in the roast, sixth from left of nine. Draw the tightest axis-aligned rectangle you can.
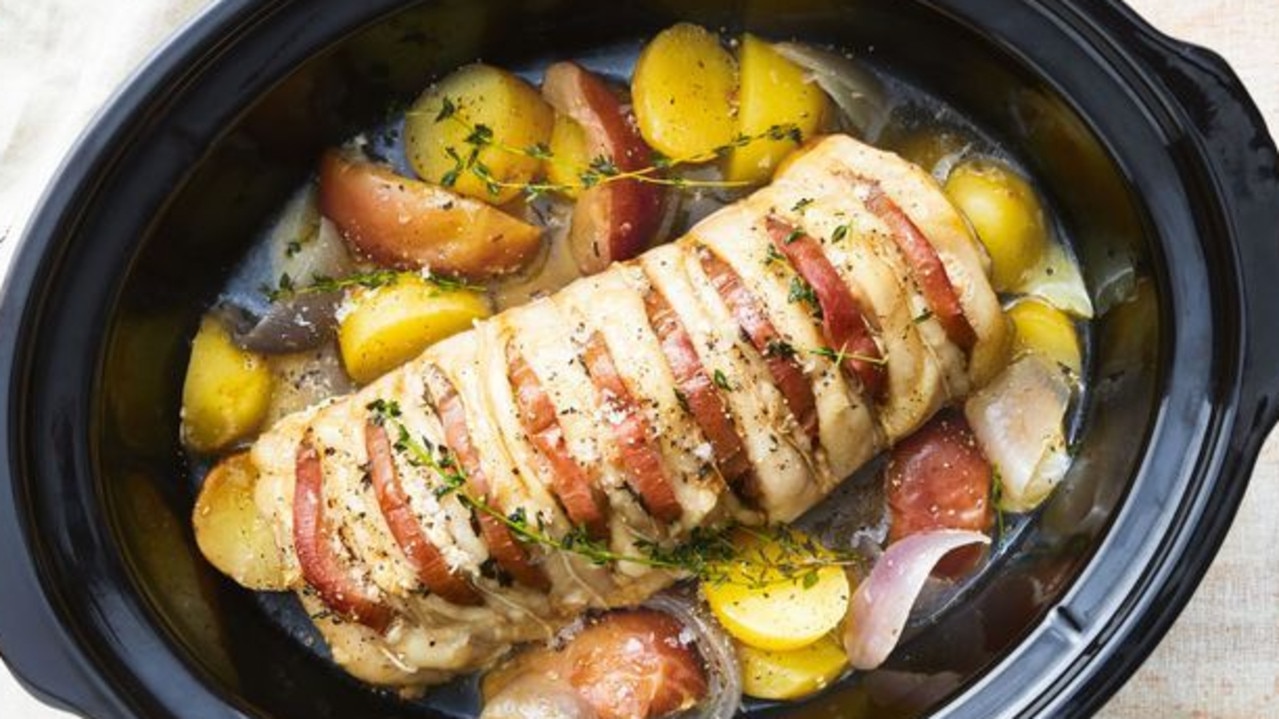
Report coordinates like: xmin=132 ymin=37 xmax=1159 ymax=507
xmin=645 ymin=282 xmax=760 ymax=502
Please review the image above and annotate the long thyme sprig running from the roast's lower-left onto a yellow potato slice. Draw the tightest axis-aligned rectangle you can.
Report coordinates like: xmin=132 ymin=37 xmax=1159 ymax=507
xmin=366 ymin=399 xmax=863 ymax=589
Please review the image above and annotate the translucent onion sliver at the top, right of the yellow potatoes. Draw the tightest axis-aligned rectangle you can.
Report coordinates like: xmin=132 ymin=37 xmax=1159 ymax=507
xmin=774 ymin=42 xmax=888 ymax=139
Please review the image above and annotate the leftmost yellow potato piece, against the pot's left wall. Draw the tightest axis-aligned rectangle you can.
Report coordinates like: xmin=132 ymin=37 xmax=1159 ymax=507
xmin=182 ymin=312 xmax=271 ymax=452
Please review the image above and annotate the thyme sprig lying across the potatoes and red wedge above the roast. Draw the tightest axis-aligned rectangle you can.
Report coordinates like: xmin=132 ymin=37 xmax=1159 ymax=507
xmin=409 ymin=97 xmax=803 ymax=200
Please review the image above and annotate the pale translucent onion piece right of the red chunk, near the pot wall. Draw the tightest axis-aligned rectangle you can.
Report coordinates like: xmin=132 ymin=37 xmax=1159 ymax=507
xmin=964 ymin=354 xmax=1071 ymax=512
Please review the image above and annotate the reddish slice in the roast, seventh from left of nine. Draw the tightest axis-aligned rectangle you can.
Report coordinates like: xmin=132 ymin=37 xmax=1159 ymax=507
xmin=700 ymin=248 xmax=819 ymax=441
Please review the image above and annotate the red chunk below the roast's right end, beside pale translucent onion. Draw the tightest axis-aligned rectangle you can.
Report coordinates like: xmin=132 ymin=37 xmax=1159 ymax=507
xmin=885 ymin=409 xmax=994 ymax=577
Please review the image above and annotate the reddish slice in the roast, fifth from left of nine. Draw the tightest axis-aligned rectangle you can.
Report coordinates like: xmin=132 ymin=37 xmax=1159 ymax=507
xmin=583 ymin=333 xmax=684 ymax=522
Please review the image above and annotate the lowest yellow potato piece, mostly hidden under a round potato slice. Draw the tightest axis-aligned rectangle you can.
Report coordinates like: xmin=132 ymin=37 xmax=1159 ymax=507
xmin=737 ymin=635 xmax=848 ymax=700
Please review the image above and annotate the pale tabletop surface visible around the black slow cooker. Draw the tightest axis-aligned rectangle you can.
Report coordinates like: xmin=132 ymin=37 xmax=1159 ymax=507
xmin=0 ymin=0 xmax=1279 ymax=719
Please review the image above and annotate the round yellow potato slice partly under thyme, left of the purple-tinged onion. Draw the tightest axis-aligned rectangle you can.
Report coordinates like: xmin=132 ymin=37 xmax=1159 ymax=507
xmin=702 ymin=530 xmax=849 ymax=651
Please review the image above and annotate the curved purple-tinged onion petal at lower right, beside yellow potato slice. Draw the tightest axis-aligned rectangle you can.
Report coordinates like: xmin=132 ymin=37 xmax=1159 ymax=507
xmin=844 ymin=530 xmax=990 ymax=669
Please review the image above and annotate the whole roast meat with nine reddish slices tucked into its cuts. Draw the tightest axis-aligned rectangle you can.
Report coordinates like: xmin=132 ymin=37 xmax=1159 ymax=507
xmin=241 ymin=136 xmax=1008 ymax=687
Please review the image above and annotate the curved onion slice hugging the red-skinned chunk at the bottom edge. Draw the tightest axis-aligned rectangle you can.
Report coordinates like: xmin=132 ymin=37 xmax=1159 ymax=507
xmin=645 ymin=591 xmax=742 ymax=719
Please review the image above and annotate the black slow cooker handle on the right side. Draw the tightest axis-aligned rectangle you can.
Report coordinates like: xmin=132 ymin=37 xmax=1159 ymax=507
xmin=1159 ymin=37 xmax=1279 ymax=437
